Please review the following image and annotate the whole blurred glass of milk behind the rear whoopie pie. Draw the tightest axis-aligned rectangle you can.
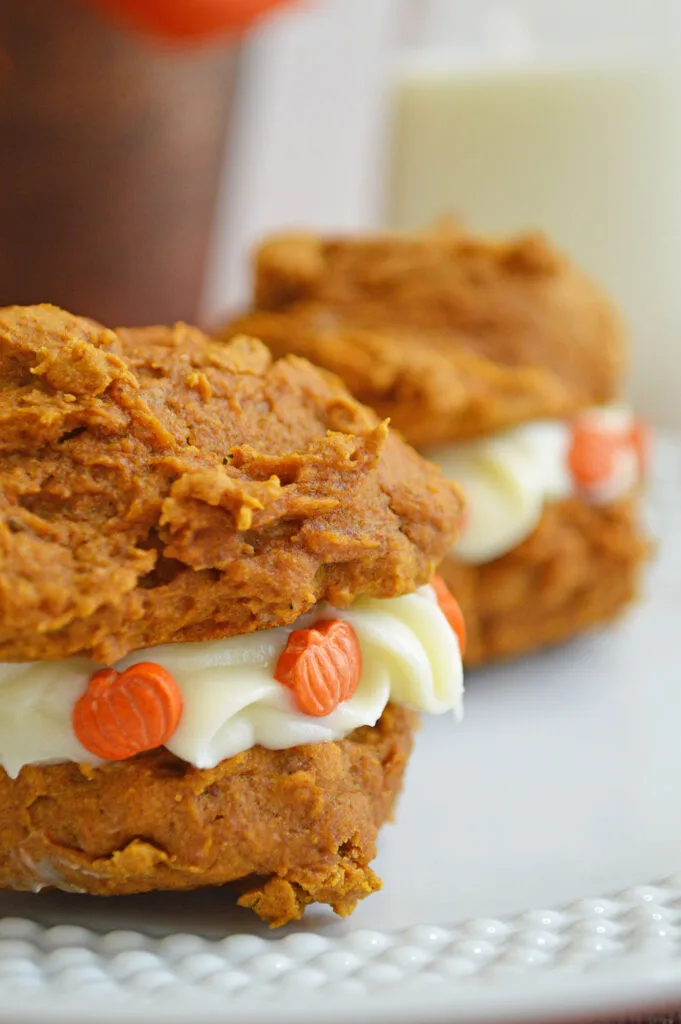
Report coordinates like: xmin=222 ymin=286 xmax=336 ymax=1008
xmin=386 ymin=0 xmax=681 ymax=427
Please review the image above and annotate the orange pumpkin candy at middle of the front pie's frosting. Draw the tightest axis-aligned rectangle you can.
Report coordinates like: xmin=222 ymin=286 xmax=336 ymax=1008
xmin=274 ymin=618 xmax=361 ymax=718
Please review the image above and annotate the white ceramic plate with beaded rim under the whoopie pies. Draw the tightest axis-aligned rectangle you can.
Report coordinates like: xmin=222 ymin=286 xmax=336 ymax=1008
xmin=0 ymin=439 xmax=681 ymax=1024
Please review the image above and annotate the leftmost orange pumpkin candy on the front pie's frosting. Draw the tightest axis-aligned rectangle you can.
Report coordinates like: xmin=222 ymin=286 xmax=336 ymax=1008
xmin=73 ymin=662 xmax=182 ymax=761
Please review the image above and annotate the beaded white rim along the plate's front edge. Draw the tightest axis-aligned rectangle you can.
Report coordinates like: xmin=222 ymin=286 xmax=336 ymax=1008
xmin=0 ymin=872 xmax=681 ymax=1024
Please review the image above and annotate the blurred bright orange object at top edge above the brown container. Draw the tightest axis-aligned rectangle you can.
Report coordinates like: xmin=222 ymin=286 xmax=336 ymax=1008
xmin=86 ymin=0 xmax=293 ymax=42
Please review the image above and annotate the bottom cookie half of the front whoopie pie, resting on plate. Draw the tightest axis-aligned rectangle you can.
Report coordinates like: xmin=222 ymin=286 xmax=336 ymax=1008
xmin=0 ymin=705 xmax=416 ymax=926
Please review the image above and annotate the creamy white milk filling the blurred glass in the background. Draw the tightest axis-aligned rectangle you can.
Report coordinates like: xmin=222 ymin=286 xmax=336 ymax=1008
xmin=388 ymin=59 xmax=681 ymax=426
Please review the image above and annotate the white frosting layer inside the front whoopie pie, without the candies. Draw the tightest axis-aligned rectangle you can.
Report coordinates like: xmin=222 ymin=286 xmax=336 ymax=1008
xmin=0 ymin=587 xmax=463 ymax=777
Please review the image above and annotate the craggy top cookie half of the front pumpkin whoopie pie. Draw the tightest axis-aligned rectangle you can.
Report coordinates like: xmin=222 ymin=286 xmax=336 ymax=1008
xmin=0 ymin=306 xmax=461 ymax=663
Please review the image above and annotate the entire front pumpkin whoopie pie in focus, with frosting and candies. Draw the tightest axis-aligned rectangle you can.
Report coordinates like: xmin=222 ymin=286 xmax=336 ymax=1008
xmin=0 ymin=306 xmax=463 ymax=925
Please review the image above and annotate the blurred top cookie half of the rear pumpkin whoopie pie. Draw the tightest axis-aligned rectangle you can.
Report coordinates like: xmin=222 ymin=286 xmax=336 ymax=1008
xmin=221 ymin=229 xmax=624 ymax=445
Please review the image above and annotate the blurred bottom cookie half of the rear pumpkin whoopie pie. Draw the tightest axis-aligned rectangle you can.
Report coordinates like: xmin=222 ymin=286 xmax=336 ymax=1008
xmin=439 ymin=499 xmax=648 ymax=668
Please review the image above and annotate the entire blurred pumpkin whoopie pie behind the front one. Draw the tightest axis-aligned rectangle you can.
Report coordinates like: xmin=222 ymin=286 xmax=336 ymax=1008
xmin=221 ymin=227 xmax=647 ymax=666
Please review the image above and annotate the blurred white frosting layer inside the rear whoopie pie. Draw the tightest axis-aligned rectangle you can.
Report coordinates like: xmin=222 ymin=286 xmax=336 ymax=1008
xmin=425 ymin=406 xmax=639 ymax=565
